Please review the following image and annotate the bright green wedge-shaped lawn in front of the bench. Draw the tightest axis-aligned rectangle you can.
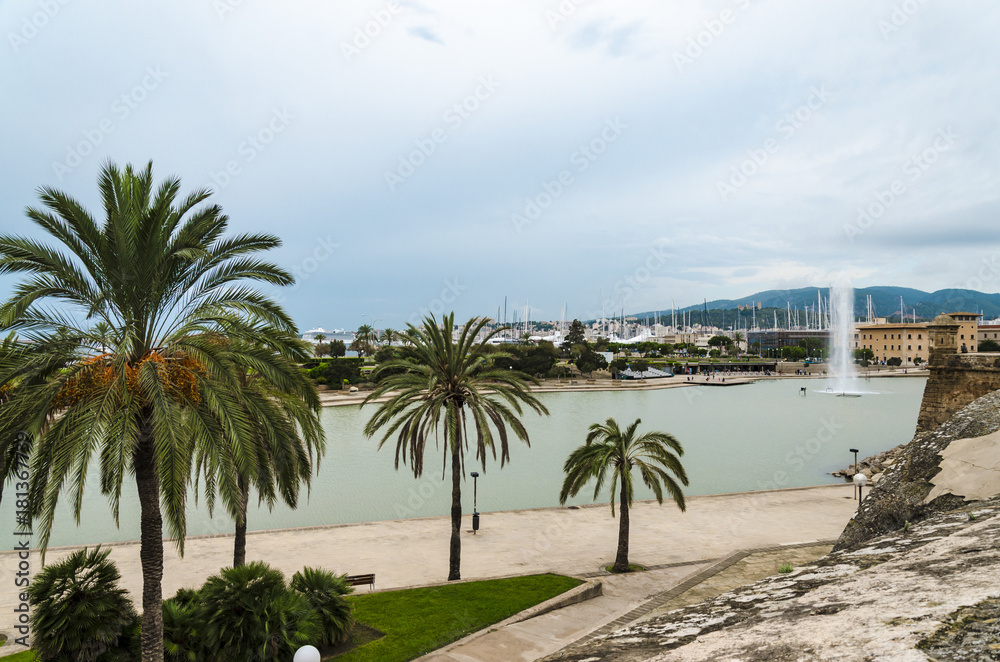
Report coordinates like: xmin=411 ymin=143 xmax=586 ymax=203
xmin=336 ymin=575 xmax=582 ymax=662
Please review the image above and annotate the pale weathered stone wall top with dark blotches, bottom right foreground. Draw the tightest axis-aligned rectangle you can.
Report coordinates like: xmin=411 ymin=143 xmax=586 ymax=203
xmin=546 ymin=499 xmax=1000 ymax=662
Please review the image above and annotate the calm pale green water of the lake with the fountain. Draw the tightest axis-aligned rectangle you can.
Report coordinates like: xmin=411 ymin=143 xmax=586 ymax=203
xmin=0 ymin=378 xmax=925 ymax=549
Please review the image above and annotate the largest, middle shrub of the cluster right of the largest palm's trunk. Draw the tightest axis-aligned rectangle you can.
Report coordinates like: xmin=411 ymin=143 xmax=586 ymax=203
xmin=199 ymin=562 xmax=322 ymax=662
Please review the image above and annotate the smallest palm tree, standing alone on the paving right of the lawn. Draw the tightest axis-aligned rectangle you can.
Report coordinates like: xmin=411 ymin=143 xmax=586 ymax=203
xmin=559 ymin=418 xmax=688 ymax=572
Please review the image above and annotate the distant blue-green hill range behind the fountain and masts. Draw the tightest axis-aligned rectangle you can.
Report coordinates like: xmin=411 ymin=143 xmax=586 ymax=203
xmin=634 ymin=286 xmax=1000 ymax=320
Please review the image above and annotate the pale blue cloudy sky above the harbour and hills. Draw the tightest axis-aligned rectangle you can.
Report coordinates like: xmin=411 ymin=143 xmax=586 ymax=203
xmin=0 ymin=0 xmax=1000 ymax=330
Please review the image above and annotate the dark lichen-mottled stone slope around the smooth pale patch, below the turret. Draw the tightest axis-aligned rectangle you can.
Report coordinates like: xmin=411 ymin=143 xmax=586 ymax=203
xmin=834 ymin=392 xmax=1000 ymax=550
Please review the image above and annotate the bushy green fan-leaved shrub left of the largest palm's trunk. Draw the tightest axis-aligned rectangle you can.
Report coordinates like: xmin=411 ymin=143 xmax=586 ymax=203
xmin=28 ymin=547 xmax=139 ymax=662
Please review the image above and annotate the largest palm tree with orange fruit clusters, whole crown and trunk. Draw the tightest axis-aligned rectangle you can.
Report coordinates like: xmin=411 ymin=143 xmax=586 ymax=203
xmin=0 ymin=163 xmax=304 ymax=662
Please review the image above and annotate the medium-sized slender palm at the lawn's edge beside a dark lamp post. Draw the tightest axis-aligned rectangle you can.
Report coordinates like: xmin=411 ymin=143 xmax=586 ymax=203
xmin=365 ymin=313 xmax=549 ymax=581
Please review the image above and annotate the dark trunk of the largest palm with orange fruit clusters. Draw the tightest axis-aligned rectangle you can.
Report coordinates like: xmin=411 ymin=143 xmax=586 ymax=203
xmin=133 ymin=416 xmax=163 ymax=662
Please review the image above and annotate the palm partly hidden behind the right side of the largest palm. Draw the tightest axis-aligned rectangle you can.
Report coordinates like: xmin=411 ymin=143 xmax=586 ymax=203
xmin=195 ymin=324 xmax=326 ymax=567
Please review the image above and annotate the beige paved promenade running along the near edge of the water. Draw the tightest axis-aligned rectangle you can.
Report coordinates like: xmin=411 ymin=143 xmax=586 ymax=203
xmin=0 ymin=484 xmax=856 ymax=660
